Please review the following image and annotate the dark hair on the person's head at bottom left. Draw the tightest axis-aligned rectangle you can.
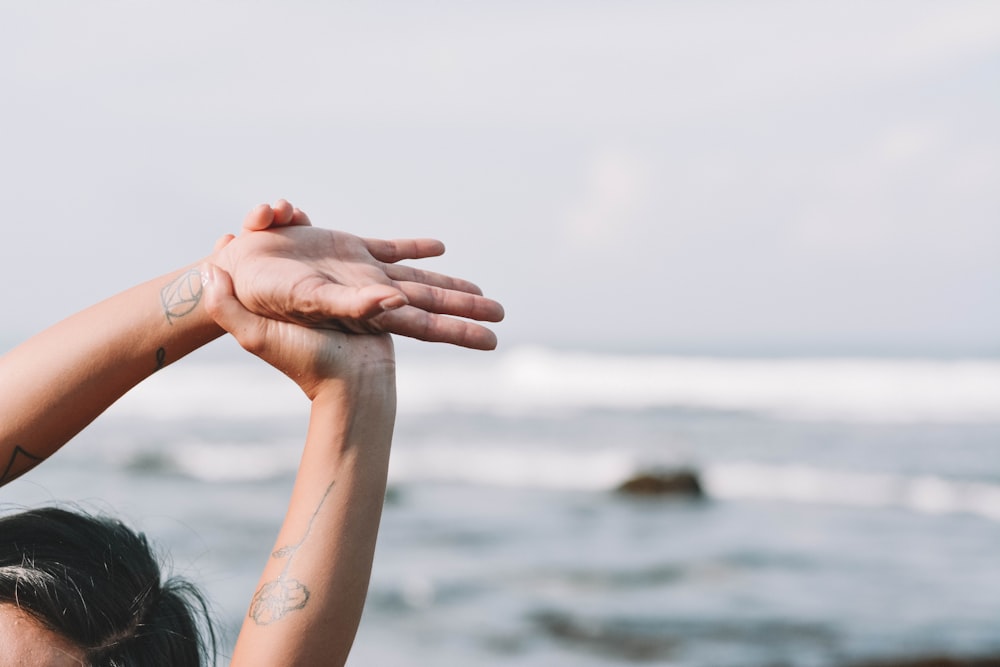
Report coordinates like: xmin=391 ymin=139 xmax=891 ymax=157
xmin=0 ymin=507 xmax=216 ymax=667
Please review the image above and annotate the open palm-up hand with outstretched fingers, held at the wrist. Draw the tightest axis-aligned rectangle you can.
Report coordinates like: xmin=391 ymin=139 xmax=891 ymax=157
xmin=211 ymin=200 xmax=504 ymax=350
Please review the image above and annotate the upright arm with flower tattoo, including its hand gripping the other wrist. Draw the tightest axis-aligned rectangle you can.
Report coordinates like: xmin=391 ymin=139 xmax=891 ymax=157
xmin=206 ymin=268 xmax=396 ymax=667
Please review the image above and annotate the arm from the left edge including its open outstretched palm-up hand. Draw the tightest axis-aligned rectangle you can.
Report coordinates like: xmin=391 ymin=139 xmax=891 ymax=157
xmin=0 ymin=200 xmax=503 ymax=485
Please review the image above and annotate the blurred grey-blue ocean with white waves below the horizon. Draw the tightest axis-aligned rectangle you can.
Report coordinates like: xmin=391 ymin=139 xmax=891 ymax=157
xmin=0 ymin=347 xmax=1000 ymax=667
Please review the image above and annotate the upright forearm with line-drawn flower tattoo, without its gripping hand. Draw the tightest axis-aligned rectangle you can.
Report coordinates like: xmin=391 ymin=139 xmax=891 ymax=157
xmin=232 ymin=368 xmax=395 ymax=667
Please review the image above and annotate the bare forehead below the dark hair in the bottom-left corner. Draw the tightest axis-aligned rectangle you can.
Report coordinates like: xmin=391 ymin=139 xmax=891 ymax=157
xmin=0 ymin=604 xmax=85 ymax=667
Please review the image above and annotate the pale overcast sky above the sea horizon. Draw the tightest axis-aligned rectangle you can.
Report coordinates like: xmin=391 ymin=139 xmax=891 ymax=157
xmin=0 ymin=0 xmax=1000 ymax=354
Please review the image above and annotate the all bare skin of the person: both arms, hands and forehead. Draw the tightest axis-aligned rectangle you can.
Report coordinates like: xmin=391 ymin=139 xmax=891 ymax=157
xmin=0 ymin=200 xmax=503 ymax=667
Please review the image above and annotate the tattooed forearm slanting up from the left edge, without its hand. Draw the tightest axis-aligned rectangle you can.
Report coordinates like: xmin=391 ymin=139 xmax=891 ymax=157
xmin=0 ymin=265 xmax=223 ymax=485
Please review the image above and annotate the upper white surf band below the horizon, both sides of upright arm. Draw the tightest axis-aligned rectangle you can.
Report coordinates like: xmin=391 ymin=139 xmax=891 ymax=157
xmin=107 ymin=347 xmax=1000 ymax=423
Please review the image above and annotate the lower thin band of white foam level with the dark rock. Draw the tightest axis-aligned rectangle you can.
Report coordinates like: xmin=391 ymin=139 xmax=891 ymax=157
xmin=150 ymin=442 xmax=1000 ymax=521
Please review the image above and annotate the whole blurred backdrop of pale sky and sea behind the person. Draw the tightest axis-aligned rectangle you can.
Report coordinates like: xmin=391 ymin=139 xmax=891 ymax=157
xmin=0 ymin=0 xmax=1000 ymax=666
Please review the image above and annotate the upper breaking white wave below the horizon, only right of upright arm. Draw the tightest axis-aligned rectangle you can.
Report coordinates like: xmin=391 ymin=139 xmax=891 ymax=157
xmin=422 ymin=348 xmax=1000 ymax=422
